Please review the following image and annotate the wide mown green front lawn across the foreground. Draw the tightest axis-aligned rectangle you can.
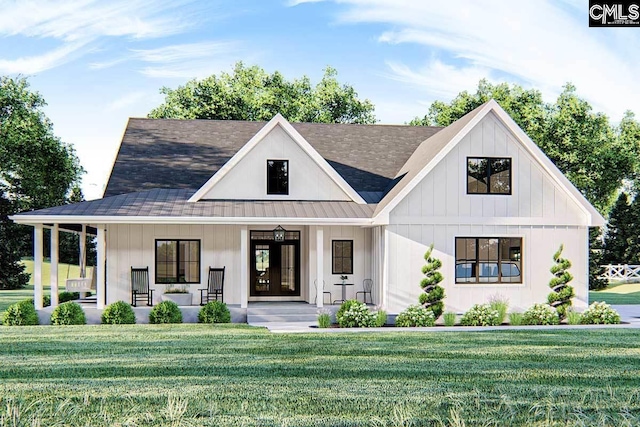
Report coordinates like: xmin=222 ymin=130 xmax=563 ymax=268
xmin=0 ymin=325 xmax=640 ymax=426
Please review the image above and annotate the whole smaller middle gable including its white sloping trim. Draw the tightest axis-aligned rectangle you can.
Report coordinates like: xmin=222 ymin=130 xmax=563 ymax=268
xmin=190 ymin=115 xmax=365 ymax=203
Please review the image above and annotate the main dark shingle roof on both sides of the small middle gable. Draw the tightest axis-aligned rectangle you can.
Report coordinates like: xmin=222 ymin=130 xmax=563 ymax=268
xmin=104 ymin=118 xmax=441 ymax=202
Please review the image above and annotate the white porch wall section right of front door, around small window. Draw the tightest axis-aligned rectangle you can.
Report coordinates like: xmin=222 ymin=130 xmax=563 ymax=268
xmin=303 ymin=226 xmax=372 ymax=304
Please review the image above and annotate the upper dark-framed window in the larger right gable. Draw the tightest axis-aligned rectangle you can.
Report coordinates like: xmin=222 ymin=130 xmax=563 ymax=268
xmin=467 ymin=157 xmax=511 ymax=194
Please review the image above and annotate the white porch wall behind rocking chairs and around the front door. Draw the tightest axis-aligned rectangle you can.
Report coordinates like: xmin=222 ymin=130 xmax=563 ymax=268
xmin=102 ymin=224 xmax=368 ymax=304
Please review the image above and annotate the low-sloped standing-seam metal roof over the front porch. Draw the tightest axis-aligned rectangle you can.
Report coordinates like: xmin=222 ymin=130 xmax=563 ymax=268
xmin=16 ymin=189 xmax=376 ymax=219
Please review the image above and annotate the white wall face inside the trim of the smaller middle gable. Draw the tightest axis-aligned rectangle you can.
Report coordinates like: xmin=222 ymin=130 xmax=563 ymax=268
xmin=203 ymin=126 xmax=351 ymax=200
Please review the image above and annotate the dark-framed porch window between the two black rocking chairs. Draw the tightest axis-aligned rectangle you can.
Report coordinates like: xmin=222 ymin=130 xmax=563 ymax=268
xmin=156 ymin=240 xmax=200 ymax=283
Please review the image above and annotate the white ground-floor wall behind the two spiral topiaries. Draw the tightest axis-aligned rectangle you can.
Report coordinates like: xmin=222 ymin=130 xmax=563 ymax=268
xmin=386 ymin=225 xmax=589 ymax=313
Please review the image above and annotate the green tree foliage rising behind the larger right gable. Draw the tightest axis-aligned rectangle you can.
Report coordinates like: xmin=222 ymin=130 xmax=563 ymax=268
xmin=410 ymin=80 xmax=640 ymax=213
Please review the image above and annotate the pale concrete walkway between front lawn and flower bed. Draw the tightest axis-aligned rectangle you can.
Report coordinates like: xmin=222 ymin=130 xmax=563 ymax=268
xmin=251 ymin=305 xmax=640 ymax=333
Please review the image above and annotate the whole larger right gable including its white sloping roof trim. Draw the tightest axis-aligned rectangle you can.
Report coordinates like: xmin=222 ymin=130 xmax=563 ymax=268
xmin=375 ymin=100 xmax=605 ymax=226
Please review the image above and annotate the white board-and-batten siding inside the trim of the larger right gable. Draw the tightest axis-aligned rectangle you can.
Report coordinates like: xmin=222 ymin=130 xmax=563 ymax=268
xmin=390 ymin=113 xmax=587 ymax=225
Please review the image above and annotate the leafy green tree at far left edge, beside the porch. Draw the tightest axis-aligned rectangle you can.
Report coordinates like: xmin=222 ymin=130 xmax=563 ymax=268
xmin=0 ymin=77 xmax=83 ymax=283
